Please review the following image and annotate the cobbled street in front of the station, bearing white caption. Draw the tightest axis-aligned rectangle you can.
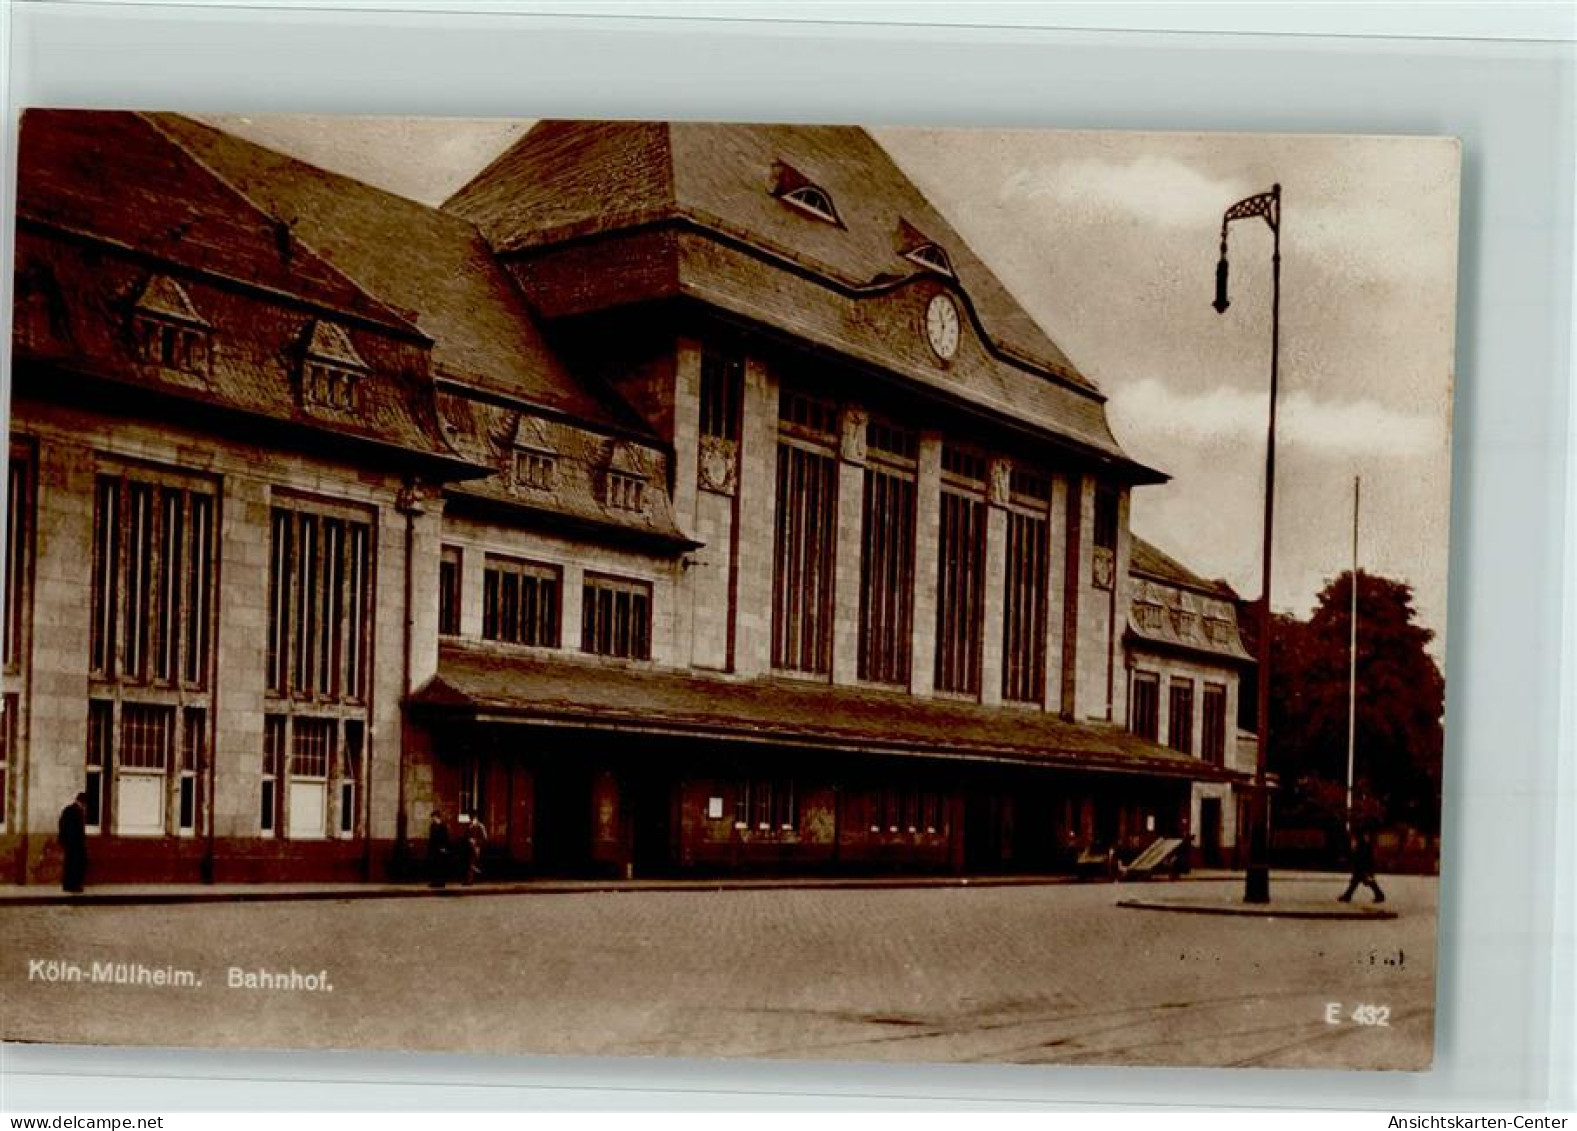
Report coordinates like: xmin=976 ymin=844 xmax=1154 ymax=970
xmin=0 ymin=877 xmax=1437 ymax=1068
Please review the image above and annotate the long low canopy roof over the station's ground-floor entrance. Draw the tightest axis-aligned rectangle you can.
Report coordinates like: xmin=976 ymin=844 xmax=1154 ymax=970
xmin=412 ymin=645 xmax=1225 ymax=779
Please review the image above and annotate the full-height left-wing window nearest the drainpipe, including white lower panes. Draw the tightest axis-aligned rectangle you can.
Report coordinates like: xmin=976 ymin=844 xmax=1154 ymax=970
xmin=268 ymin=502 xmax=374 ymax=841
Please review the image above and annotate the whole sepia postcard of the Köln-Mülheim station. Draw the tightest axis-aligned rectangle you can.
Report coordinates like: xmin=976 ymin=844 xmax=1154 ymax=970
xmin=0 ymin=107 xmax=1460 ymax=1071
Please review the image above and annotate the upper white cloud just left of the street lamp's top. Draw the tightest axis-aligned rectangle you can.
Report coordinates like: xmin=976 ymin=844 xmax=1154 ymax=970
xmin=1003 ymin=155 xmax=1247 ymax=227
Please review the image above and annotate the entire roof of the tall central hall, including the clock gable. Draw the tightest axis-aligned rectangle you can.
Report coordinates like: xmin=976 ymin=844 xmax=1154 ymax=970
xmin=445 ymin=121 xmax=1164 ymax=481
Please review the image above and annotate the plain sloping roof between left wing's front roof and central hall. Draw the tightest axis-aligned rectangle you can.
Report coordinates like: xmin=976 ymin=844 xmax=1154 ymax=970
xmin=141 ymin=114 xmax=643 ymax=431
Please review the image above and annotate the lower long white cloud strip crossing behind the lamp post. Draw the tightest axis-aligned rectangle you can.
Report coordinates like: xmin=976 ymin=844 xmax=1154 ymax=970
xmin=1109 ymin=377 xmax=1446 ymax=457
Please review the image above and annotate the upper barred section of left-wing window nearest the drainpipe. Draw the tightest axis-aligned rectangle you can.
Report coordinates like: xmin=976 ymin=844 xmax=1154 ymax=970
xmin=268 ymin=506 xmax=372 ymax=702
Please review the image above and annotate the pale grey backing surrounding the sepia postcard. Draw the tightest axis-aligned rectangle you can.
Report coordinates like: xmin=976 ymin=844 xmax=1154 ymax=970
xmin=0 ymin=0 xmax=1577 ymax=1112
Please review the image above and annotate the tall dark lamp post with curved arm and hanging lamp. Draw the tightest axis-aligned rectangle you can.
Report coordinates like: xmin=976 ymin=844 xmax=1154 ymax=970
xmin=1211 ymin=185 xmax=1281 ymax=904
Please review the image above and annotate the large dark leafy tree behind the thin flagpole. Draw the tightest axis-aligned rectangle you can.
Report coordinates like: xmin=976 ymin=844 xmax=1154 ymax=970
xmin=1248 ymin=571 xmax=1446 ymax=833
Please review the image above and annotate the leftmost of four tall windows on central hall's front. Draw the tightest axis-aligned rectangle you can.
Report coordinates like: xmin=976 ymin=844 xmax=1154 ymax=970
xmin=773 ymin=390 xmax=837 ymax=675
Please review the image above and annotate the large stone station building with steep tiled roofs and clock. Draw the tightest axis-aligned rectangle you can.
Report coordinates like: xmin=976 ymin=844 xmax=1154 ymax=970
xmin=0 ymin=112 xmax=1246 ymax=882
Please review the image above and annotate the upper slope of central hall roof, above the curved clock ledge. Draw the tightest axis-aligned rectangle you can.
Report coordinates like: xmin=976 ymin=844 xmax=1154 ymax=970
xmin=445 ymin=121 xmax=1093 ymax=388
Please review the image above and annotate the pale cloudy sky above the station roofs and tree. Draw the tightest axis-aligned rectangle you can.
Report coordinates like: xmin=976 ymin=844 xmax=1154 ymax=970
xmin=208 ymin=117 xmax=1459 ymax=661
